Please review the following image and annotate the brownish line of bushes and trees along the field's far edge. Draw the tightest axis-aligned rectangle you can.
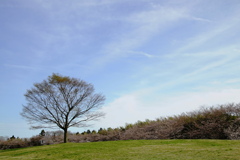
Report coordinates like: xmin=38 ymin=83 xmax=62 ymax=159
xmin=0 ymin=103 xmax=240 ymax=149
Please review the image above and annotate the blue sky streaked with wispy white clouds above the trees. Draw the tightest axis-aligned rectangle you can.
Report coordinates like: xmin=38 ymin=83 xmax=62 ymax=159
xmin=0 ymin=0 xmax=240 ymax=137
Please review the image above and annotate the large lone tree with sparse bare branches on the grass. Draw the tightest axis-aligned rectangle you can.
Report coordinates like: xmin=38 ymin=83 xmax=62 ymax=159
xmin=21 ymin=74 xmax=105 ymax=143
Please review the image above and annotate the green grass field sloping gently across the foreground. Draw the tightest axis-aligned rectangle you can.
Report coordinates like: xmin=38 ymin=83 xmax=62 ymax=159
xmin=0 ymin=140 xmax=240 ymax=160
